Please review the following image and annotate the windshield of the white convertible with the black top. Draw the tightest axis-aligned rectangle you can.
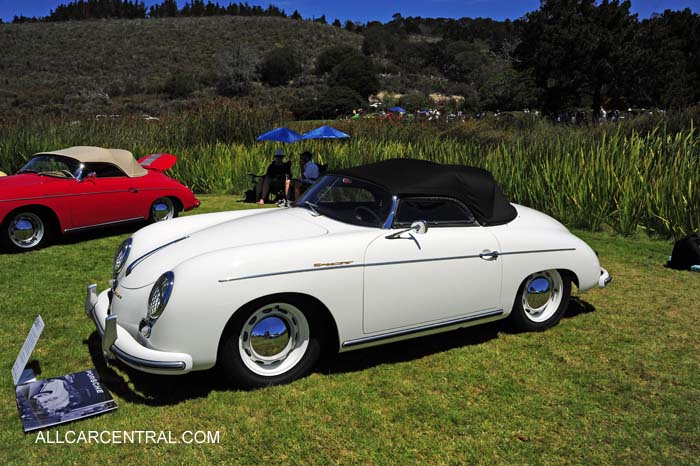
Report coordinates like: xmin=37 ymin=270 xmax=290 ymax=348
xmin=296 ymin=175 xmax=392 ymax=228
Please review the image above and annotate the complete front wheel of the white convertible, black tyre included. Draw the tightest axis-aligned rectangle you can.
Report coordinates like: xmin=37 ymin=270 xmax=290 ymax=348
xmin=220 ymin=297 xmax=322 ymax=388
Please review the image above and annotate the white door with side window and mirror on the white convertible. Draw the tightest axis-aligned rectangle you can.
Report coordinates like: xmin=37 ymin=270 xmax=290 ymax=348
xmin=363 ymin=198 xmax=501 ymax=333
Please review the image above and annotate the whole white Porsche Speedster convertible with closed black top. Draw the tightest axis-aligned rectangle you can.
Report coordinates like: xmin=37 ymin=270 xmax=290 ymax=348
xmin=85 ymin=159 xmax=611 ymax=387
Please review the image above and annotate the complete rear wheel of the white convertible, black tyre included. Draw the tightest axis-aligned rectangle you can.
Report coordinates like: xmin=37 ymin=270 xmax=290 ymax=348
xmin=511 ymin=270 xmax=571 ymax=331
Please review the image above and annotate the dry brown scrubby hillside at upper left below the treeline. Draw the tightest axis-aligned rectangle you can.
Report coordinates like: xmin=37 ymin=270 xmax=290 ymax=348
xmin=0 ymin=16 xmax=362 ymax=121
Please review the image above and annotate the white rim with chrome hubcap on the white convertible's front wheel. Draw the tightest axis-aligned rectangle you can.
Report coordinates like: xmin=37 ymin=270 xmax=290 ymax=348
xmin=238 ymin=303 xmax=309 ymax=377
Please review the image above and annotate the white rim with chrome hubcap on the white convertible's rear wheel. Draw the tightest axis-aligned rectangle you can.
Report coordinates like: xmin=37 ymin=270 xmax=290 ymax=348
xmin=522 ymin=270 xmax=564 ymax=322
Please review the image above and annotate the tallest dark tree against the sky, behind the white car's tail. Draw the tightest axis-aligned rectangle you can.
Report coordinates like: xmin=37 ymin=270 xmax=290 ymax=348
xmin=515 ymin=0 xmax=636 ymax=115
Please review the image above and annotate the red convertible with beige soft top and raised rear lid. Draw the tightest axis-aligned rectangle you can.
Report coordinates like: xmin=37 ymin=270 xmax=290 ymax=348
xmin=0 ymin=146 xmax=199 ymax=251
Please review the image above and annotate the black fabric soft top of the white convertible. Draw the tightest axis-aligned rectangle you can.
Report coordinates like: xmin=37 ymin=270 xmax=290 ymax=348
xmin=329 ymin=159 xmax=518 ymax=225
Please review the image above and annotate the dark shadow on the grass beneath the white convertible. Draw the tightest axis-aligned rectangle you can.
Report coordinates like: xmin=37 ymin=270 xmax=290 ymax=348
xmin=83 ymin=297 xmax=595 ymax=406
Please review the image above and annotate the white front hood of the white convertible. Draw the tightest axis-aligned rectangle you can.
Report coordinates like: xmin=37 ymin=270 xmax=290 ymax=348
xmin=119 ymin=209 xmax=328 ymax=289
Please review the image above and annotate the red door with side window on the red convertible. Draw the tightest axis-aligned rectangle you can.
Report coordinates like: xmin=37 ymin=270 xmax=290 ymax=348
xmin=71 ymin=163 xmax=143 ymax=228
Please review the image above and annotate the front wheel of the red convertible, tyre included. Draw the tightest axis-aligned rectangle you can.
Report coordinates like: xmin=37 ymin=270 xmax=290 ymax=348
xmin=2 ymin=210 xmax=51 ymax=252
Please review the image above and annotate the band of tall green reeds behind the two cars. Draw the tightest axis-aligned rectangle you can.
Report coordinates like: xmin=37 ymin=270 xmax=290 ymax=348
xmin=0 ymin=104 xmax=700 ymax=237
